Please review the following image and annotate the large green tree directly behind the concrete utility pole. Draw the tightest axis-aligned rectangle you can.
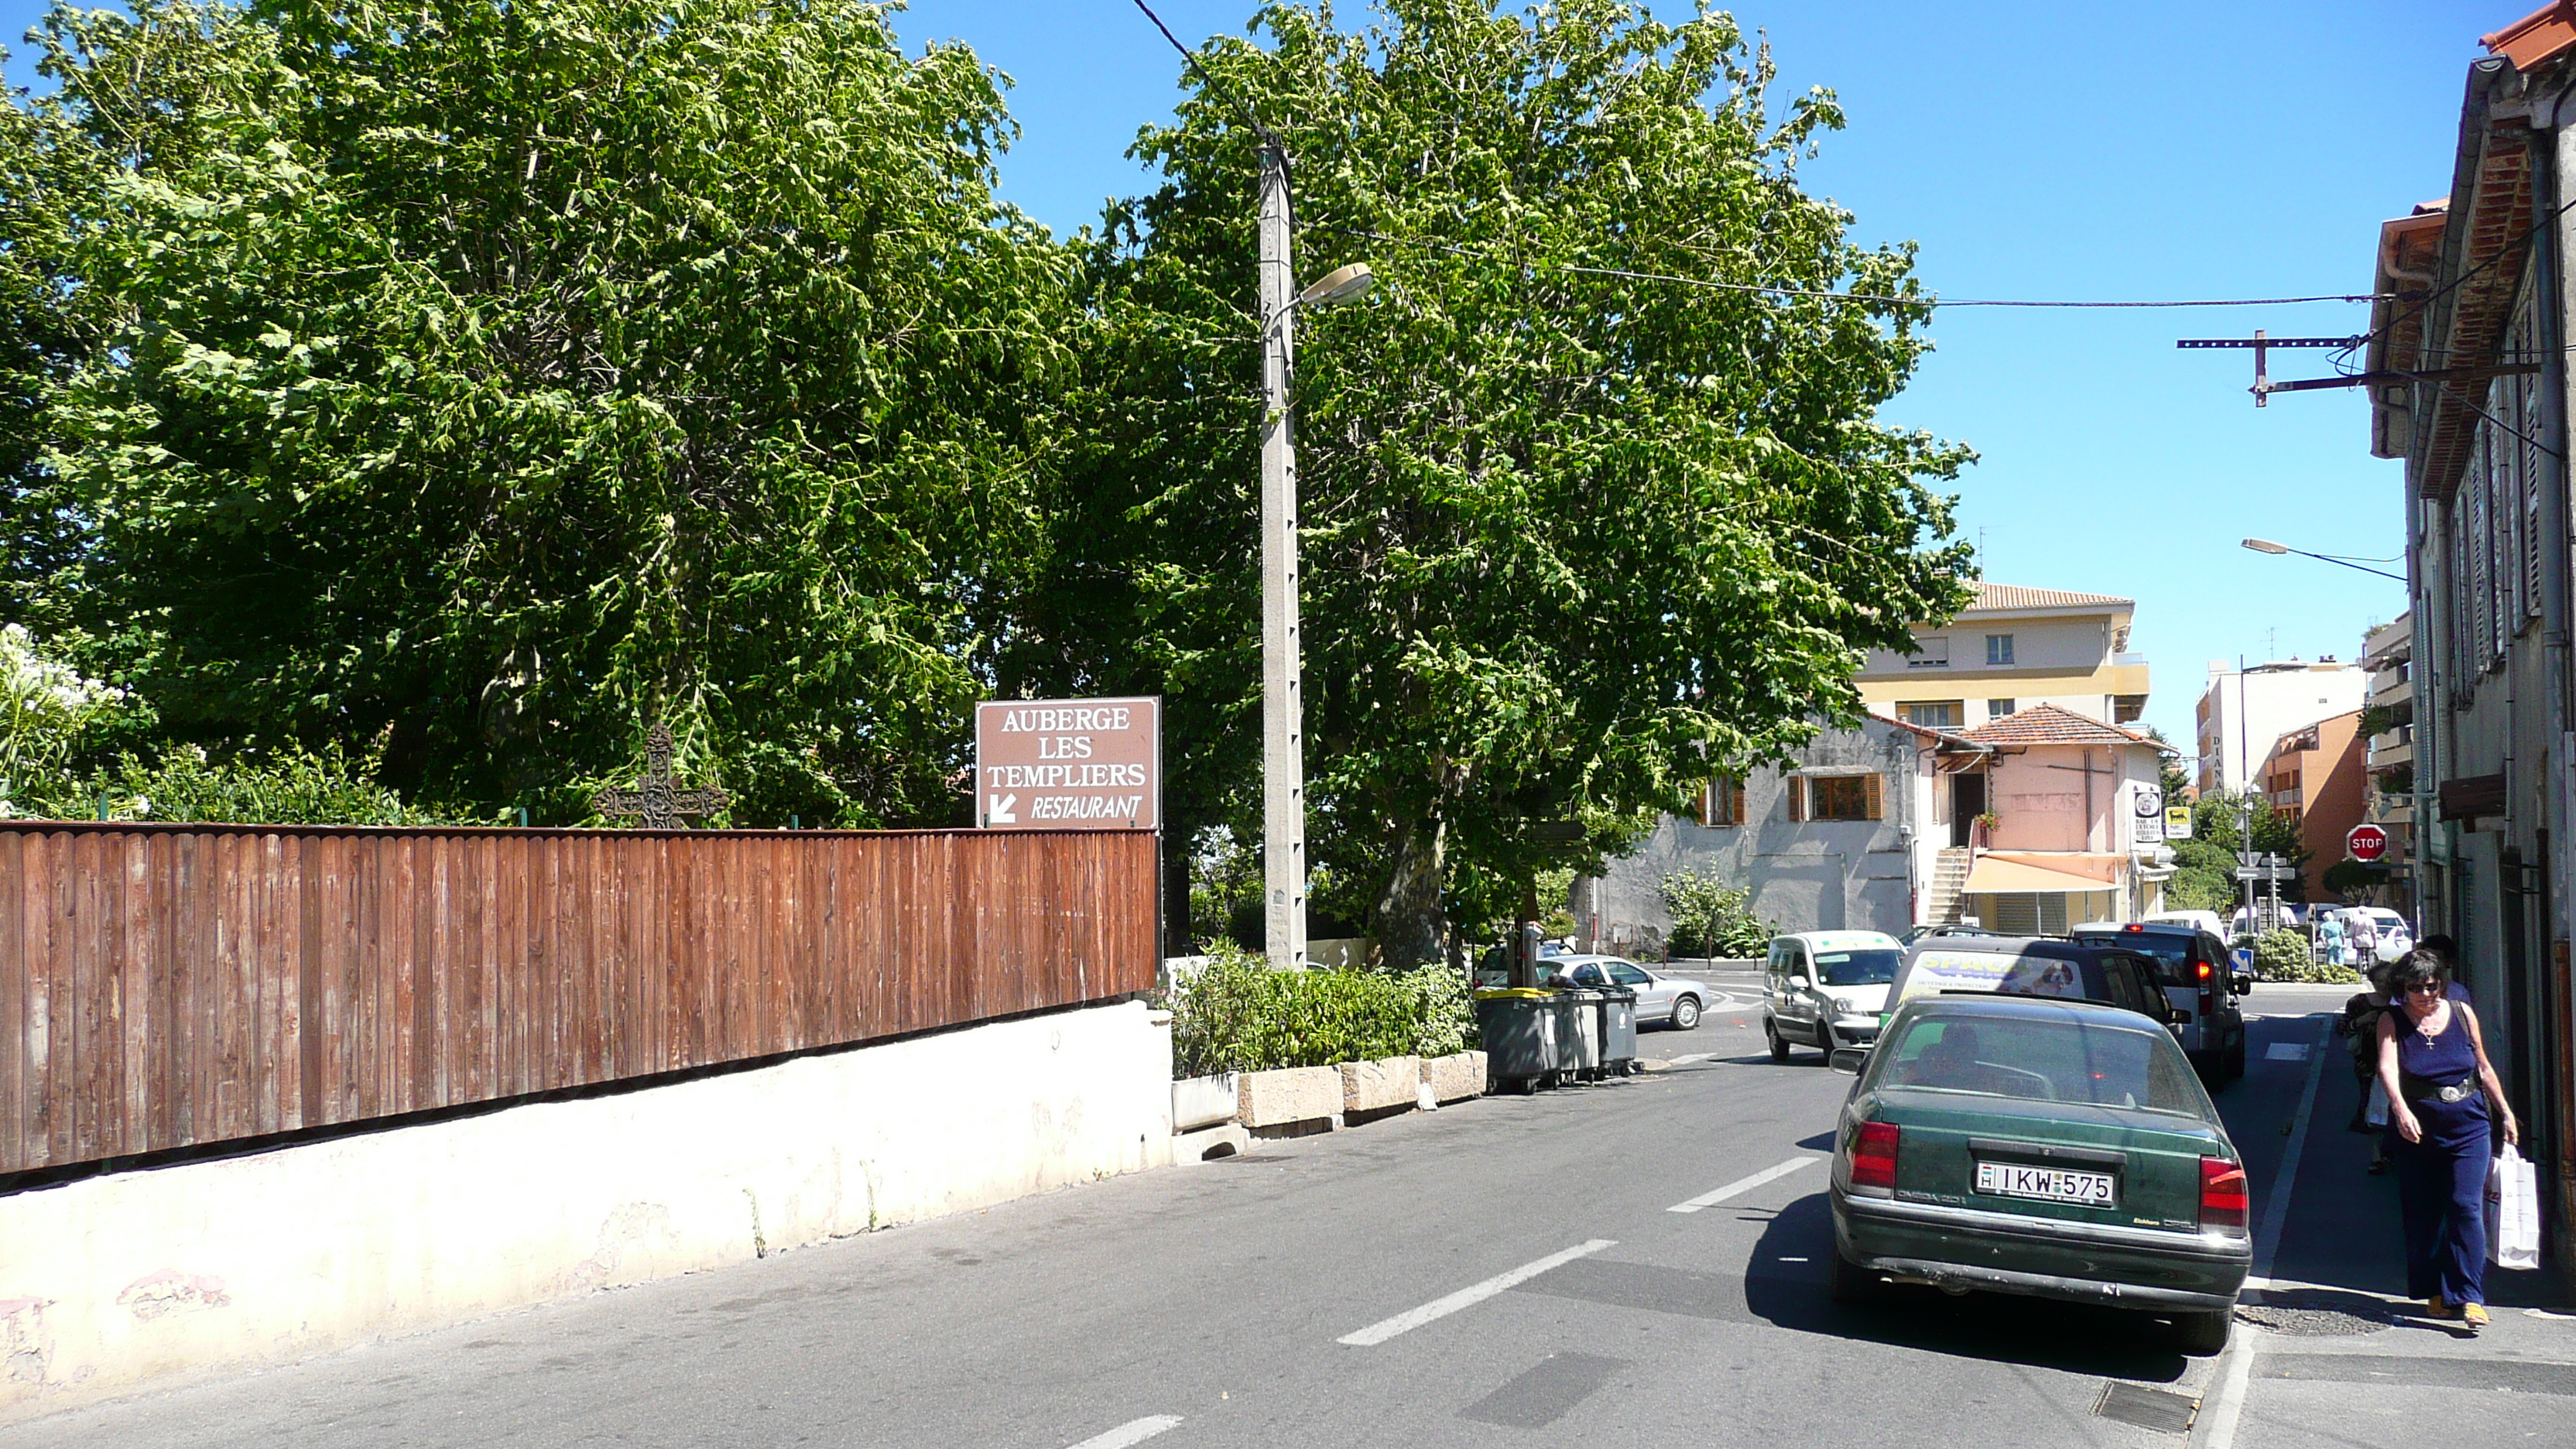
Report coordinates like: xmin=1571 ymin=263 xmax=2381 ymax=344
xmin=1061 ymin=0 xmax=1968 ymax=959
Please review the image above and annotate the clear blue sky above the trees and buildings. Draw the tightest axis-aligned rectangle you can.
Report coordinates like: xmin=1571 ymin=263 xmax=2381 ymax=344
xmin=0 ymin=0 xmax=2493 ymax=742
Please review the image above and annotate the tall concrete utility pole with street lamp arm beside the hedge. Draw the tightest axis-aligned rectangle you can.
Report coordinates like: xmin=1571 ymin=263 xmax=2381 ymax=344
xmin=1259 ymin=142 xmax=1375 ymax=972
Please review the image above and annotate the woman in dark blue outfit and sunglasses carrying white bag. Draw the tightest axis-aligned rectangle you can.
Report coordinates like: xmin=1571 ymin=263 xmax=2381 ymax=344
xmin=2380 ymin=949 xmax=2522 ymax=1333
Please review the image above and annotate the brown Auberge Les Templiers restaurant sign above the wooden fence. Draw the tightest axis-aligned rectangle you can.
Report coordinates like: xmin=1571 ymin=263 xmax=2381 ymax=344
xmin=974 ymin=696 xmax=1162 ymax=831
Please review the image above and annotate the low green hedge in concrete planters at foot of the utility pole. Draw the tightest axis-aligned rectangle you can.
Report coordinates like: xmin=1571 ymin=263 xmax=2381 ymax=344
xmin=1170 ymin=944 xmax=1476 ymax=1077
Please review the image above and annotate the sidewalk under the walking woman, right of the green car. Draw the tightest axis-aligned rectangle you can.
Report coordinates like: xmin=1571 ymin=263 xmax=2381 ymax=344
xmin=2192 ymin=1021 xmax=2576 ymax=1449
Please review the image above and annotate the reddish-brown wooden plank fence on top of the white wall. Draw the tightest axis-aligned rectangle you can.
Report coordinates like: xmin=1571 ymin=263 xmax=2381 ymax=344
xmin=0 ymin=823 xmax=1156 ymax=1173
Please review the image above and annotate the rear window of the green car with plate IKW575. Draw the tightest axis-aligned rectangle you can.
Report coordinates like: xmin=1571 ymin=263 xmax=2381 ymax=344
xmin=1870 ymin=1016 xmax=2205 ymax=1116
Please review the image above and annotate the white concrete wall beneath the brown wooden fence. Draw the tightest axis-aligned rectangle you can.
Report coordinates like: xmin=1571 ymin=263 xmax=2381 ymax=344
xmin=0 ymin=1003 xmax=1172 ymax=1423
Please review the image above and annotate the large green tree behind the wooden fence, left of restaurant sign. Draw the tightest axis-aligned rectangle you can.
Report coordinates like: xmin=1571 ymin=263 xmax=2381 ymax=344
xmin=17 ymin=0 xmax=1071 ymax=823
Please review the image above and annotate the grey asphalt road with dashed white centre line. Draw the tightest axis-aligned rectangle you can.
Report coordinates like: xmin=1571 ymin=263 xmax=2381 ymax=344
xmin=0 ymin=982 xmax=2576 ymax=1449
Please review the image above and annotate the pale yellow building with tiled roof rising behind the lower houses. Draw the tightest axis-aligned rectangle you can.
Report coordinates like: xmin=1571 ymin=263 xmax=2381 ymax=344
xmin=1855 ymin=583 xmax=2146 ymax=730
